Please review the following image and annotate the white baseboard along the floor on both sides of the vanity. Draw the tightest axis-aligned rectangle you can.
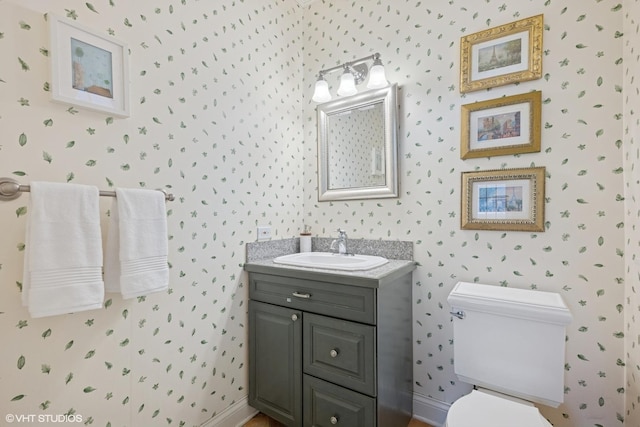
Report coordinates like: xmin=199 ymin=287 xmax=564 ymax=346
xmin=200 ymin=393 xmax=451 ymax=427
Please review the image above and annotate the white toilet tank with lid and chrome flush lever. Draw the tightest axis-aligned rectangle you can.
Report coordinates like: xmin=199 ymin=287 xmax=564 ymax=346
xmin=448 ymin=282 xmax=571 ymax=407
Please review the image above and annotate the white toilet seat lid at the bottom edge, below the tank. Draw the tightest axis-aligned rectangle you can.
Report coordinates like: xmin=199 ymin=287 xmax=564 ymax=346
xmin=445 ymin=390 xmax=552 ymax=427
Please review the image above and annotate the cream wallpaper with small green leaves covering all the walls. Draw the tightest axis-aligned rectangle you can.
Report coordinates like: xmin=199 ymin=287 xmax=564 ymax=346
xmin=0 ymin=0 xmax=640 ymax=427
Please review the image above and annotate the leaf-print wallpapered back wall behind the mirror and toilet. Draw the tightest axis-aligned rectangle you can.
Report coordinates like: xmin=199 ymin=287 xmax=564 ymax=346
xmin=304 ymin=0 xmax=624 ymax=427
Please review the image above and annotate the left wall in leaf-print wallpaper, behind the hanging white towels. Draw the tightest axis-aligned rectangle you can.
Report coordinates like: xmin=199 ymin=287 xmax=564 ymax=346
xmin=0 ymin=0 xmax=303 ymax=426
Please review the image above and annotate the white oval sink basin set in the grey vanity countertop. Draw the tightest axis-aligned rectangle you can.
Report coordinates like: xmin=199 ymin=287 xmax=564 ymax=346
xmin=273 ymin=252 xmax=389 ymax=271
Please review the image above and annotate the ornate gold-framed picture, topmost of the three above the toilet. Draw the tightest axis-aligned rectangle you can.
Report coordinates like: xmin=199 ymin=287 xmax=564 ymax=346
xmin=460 ymin=15 xmax=544 ymax=93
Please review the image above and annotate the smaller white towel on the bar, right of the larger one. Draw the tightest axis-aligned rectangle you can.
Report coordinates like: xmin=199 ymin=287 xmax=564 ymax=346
xmin=104 ymin=188 xmax=169 ymax=299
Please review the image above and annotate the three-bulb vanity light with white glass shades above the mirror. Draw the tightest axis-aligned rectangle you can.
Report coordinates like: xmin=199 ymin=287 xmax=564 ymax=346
xmin=311 ymin=53 xmax=389 ymax=103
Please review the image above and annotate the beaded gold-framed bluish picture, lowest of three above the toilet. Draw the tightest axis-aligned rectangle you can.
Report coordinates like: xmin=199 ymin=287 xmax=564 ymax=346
xmin=460 ymin=167 xmax=545 ymax=231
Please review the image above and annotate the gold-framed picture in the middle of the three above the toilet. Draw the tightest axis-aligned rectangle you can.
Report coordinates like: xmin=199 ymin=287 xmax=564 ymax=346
xmin=460 ymin=91 xmax=542 ymax=159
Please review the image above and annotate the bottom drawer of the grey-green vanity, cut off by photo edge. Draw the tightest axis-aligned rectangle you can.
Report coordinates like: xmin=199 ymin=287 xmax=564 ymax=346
xmin=303 ymin=375 xmax=377 ymax=427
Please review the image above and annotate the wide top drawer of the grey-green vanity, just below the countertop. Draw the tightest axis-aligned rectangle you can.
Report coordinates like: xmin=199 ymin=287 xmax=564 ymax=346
xmin=249 ymin=273 xmax=376 ymax=324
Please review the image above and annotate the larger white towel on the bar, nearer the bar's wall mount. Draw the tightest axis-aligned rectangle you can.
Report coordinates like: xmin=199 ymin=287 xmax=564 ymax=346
xmin=22 ymin=182 xmax=104 ymax=317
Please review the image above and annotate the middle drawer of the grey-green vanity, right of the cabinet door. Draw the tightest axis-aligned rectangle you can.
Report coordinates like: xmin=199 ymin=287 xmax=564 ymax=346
xmin=302 ymin=313 xmax=376 ymax=396
